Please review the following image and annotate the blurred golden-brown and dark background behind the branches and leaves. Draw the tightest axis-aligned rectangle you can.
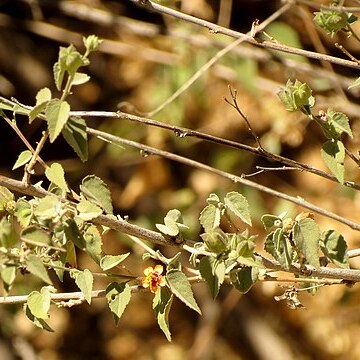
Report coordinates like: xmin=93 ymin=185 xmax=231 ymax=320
xmin=0 ymin=0 xmax=360 ymax=360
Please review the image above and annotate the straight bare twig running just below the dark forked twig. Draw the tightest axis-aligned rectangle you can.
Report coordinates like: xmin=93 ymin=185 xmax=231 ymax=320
xmin=87 ymin=128 xmax=360 ymax=231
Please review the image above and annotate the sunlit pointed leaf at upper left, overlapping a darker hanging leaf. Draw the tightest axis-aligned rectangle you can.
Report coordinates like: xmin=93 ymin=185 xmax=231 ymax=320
xmin=45 ymin=99 xmax=70 ymax=143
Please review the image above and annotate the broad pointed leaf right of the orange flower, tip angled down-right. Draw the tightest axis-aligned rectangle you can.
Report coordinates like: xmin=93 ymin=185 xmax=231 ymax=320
xmin=166 ymin=270 xmax=201 ymax=315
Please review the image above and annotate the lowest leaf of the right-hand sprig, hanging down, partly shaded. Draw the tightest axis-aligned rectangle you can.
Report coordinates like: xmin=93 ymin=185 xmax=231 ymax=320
xmin=321 ymin=140 xmax=345 ymax=184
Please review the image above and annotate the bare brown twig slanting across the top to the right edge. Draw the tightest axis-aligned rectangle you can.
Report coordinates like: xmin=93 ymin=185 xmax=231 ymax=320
xmin=129 ymin=0 xmax=360 ymax=69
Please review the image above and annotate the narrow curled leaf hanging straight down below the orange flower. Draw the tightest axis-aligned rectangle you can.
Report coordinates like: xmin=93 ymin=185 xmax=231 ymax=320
xmin=153 ymin=286 xmax=174 ymax=341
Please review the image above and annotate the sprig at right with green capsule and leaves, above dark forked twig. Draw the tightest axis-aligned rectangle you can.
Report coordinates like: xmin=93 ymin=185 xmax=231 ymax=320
xmin=278 ymin=80 xmax=353 ymax=184
